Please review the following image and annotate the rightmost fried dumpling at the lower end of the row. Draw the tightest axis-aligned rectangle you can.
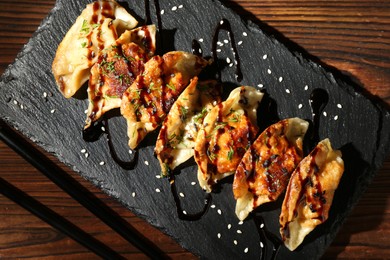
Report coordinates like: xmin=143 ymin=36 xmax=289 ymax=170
xmin=280 ymin=139 xmax=344 ymax=251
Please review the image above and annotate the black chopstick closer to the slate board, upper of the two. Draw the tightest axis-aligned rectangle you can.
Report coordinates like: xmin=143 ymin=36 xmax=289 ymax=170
xmin=0 ymin=120 xmax=167 ymax=259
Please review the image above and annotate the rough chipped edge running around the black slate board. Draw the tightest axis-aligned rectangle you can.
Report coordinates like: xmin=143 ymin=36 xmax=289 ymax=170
xmin=1 ymin=0 xmax=390 ymax=258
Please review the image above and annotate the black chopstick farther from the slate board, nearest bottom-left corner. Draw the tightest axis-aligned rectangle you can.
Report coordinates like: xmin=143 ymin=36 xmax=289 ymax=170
xmin=0 ymin=177 xmax=123 ymax=259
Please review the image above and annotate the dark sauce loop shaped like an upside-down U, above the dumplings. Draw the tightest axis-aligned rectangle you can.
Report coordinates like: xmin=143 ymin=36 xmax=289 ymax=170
xmin=212 ymin=19 xmax=243 ymax=82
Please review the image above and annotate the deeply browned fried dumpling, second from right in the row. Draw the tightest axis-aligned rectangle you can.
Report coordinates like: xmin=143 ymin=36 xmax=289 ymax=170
xmin=233 ymin=118 xmax=309 ymax=220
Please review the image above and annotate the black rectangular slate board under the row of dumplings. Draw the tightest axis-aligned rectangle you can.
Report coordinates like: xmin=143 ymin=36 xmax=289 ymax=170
xmin=0 ymin=0 xmax=390 ymax=259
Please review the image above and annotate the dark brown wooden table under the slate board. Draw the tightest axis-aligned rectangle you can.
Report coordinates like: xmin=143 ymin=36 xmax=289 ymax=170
xmin=0 ymin=0 xmax=390 ymax=259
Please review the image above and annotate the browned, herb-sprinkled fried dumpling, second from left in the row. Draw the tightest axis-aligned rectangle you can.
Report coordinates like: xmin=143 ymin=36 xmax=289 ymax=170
xmin=85 ymin=25 xmax=156 ymax=128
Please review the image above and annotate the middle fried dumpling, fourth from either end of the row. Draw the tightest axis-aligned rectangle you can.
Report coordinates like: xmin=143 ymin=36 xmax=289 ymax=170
xmin=155 ymin=77 xmax=221 ymax=176
